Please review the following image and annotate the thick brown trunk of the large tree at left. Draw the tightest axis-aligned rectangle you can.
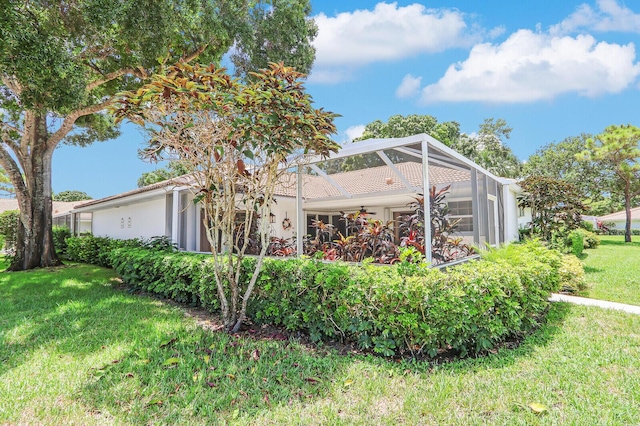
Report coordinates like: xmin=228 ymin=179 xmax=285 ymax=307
xmin=8 ymin=117 xmax=62 ymax=271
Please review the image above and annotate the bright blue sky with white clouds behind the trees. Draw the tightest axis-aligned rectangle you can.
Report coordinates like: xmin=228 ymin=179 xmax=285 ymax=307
xmin=53 ymin=0 xmax=640 ymax=198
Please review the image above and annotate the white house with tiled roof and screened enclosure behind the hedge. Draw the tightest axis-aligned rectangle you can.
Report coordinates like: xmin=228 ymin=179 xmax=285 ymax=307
xmin=71 ymin=134 xmax=521 ymax=260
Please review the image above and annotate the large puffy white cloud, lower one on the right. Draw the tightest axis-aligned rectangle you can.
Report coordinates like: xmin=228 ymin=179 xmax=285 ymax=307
xmin=421 ymin=30 xmax=640 ymax=103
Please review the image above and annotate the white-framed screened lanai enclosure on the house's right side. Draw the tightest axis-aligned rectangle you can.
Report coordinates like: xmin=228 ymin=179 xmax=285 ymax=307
xmin=296 ymin=134 xmax=520 ymax=264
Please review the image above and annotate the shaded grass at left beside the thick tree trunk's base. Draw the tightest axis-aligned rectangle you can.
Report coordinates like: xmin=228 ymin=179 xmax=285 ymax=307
xmin=0 ymin=265 xmax=172 ymax=375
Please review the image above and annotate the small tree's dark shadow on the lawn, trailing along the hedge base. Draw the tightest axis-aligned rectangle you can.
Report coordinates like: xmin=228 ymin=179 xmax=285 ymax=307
xmin=76 ymin=303 xmax=571 ymax=423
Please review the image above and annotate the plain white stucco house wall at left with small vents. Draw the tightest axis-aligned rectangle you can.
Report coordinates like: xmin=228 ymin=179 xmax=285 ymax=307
xmin=92 ymin=197 xmax=166 ymax=239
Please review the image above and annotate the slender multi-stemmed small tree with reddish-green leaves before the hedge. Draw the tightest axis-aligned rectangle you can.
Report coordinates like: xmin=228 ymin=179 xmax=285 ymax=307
xmin=114 ymin=63 xmax=339 ymax=332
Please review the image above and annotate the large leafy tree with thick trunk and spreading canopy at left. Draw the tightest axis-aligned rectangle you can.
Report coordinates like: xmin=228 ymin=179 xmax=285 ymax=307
xmin=0 ymin=0 xmax=315 ymax=270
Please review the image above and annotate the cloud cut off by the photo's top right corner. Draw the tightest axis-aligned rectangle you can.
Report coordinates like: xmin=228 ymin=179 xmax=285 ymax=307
xmin=550 ymin=0 xmax=640 ymax=35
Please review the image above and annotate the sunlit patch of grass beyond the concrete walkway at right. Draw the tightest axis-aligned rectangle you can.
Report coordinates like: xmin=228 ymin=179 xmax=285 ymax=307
xmin=582 ymin=235 xmax=640 ymax=305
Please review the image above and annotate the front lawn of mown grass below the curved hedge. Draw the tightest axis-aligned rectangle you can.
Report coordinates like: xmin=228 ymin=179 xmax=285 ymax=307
xmin=0 ymin=258 xmax=640 ymax=425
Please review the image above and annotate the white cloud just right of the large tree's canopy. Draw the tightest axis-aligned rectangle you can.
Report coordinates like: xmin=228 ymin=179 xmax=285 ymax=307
xmin=310 ymin=3 xmax=480 ymax=82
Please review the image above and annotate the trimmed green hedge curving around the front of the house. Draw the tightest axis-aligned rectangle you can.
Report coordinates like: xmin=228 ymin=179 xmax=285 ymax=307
xmin=67 ymin=237 xmax=577 ymax=356
